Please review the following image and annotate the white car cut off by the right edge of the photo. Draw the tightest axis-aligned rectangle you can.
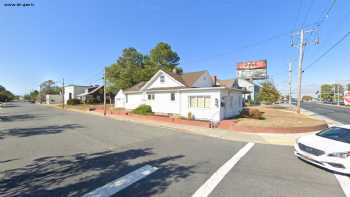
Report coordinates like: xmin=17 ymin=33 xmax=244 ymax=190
xmin=294 ymin=125 xmax=350 ymax=175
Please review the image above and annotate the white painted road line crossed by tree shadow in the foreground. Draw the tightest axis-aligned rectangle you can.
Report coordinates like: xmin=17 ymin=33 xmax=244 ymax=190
xmin=84 ymin=165 xmax=158 ymax=197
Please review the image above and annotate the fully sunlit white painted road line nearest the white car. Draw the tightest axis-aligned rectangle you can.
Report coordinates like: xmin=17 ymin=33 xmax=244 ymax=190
xmin=192 ymin=142 xmax=254 ymax=197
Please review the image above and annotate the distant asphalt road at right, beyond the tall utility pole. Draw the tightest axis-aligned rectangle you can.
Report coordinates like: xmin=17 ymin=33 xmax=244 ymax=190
xmin=302 ymin=102 xmax=350 ymax=124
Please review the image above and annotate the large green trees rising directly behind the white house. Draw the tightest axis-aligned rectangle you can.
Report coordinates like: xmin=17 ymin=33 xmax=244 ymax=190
xmin=106 ymin=42 xmax=182 ymax=93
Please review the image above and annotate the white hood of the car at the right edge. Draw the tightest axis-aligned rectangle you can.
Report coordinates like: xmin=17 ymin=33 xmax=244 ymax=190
xmin=298 ymin=134 xmax=350 ymax=153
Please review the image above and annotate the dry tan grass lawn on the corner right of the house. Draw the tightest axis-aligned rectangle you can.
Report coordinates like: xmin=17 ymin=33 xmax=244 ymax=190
xmin=234 ymin=106 xmax=325 ymax=128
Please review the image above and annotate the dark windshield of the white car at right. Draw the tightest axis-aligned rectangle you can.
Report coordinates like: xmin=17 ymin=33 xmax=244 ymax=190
xmin=317 ymin=127 xmax=350 ymax=144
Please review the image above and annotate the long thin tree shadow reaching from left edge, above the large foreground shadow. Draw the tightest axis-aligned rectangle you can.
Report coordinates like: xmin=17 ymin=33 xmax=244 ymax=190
xmin=0 ymin=124 xmax=82 ymax=139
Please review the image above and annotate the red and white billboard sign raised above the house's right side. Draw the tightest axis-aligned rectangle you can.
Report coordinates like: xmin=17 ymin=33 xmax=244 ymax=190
xmin=237 ymin=60 xmax=267 ymax=80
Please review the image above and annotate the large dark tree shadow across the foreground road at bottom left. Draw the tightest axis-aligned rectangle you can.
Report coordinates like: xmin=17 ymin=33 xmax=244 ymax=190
xmin=0 ymin=148 xmax=195 ymax=196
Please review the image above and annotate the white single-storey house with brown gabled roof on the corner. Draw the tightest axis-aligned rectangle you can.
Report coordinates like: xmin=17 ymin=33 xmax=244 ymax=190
xmin=115 ymin=70 xmax=243 ymax=121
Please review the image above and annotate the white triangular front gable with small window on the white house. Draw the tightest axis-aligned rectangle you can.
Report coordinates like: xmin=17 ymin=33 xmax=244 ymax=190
xmin=141 ymin=70 xmax=185 ymax=90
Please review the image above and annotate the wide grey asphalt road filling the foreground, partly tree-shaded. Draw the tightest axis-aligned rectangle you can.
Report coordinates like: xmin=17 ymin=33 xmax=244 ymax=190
xmin=0 ymin=103 xmax=345 ymax=197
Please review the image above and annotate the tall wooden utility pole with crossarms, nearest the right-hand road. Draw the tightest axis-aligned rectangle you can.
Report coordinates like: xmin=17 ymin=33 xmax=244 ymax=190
xmin=292 ymin=28 xmax=319 ymax=114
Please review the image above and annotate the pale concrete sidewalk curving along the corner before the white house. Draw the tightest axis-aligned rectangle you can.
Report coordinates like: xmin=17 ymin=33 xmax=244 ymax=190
xmin=50 ymin=105 xmax=317 ymax=146
